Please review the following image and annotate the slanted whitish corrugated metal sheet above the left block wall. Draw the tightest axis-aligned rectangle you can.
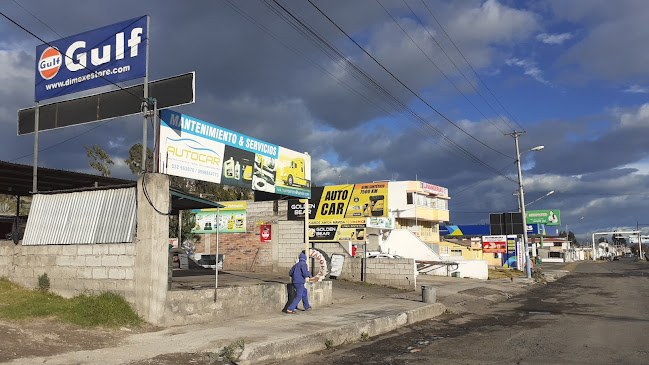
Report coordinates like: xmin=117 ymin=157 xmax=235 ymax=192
xmin=23 ymin=187 xmax=136 ymax=246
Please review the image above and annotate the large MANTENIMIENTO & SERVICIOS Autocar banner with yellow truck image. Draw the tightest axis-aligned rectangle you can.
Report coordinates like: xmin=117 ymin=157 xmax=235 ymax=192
xmin=158 ymin=109 xmax=311 ymax=198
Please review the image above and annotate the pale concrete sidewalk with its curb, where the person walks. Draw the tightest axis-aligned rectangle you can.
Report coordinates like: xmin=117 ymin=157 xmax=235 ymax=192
xmin=6 ymin=265 xmax=574 ymax=364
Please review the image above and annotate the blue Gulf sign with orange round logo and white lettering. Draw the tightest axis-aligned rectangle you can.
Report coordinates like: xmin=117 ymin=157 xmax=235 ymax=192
xmin=34 ymin=16 xmax=148 ymax=101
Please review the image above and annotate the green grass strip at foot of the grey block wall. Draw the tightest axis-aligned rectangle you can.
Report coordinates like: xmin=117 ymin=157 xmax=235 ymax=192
xmin=0 ymin=279 xmax=143 ymax=327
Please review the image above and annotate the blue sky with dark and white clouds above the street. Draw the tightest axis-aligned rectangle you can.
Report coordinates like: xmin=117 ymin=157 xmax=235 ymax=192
xmin=0 ymin=0 xmax=649 ymax=239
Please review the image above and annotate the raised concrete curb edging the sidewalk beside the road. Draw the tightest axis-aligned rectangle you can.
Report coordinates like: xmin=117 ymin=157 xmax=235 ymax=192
xmin=237 ymin=303 xmax=446 ymax=365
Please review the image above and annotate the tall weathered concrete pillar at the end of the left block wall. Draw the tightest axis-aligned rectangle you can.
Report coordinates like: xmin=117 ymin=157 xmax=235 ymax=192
xmin=135 ymin=174 xmax=170 ymax=324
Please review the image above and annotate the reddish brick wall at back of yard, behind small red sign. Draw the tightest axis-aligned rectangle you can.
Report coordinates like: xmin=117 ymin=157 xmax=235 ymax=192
xmin=196 ymin=200 xmax=288 ymax=272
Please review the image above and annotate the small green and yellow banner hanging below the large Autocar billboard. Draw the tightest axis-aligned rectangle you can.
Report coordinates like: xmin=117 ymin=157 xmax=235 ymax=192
xmin=191 ymin=201 xmax=246 ymax=233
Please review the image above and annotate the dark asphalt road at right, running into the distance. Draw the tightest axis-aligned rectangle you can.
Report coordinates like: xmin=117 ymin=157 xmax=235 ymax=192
xmin=293 ymin=260 xmax=649 ymax=365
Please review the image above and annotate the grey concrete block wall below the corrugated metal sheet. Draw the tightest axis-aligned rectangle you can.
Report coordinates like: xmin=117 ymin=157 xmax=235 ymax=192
xmin=0 ymin=243 xmax=135 ymax=303
